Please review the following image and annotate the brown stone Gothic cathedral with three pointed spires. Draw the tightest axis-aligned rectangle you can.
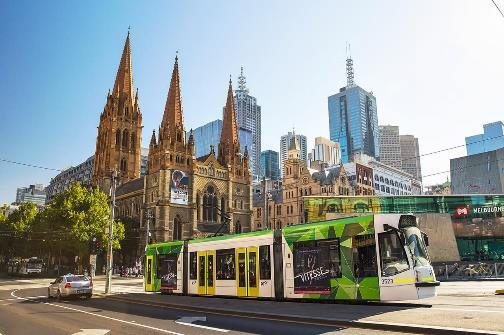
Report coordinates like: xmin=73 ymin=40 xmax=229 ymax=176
xmin=93 ymin=33 xmax=252 ymax=255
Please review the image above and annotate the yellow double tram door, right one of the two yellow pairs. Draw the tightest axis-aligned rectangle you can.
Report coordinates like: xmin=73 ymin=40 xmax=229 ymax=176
xmin=236 ymin=247 xmax=259 ymax=297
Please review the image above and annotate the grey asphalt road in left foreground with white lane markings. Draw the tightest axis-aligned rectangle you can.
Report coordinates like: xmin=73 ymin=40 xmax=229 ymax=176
xmin=0 ymin=288 xmax=418 ymax=335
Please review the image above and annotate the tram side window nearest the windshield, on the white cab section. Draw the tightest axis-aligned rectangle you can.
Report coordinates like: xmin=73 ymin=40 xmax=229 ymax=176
xmin=378 ymin=231 xmax=409 ymax=276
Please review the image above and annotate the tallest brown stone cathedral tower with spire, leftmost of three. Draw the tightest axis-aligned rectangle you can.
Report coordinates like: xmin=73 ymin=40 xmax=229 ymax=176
xmin=93 ymin=31 xmax=142 ymax=193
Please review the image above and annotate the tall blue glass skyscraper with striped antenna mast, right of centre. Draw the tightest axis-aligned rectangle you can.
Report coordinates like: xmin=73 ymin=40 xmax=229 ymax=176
xmin=328 ymin=58 xmax=380 ymax=163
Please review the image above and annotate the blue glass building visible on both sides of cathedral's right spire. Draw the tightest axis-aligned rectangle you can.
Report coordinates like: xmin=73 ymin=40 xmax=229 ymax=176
xmin=193 ymin=119 xmax=254 ymax=164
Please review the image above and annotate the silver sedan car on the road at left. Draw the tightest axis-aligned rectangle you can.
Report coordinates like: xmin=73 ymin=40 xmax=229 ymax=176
xmin=47 ymin=274 xmax=93 ymax=299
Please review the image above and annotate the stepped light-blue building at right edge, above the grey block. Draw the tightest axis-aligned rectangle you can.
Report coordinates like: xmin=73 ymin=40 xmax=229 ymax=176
xmin=466 ymin=121 xmax=504 ymax=155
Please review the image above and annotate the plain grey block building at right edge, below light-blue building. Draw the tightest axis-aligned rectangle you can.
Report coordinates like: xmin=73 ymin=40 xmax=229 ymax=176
xmin=450 ymin=148 xmax=504 ymax=194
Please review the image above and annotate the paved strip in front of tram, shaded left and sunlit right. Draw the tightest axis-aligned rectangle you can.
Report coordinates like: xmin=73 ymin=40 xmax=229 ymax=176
xmin=106 ymin=293 xmax=504 ymax=334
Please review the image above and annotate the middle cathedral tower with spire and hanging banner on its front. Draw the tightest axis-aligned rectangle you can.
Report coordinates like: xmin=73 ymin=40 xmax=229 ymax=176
xmin=144 ymin=56 xmax=195 ymax=241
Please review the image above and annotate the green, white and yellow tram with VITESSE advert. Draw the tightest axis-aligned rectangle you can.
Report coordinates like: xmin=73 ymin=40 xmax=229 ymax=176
xmin=145 ymin=214 xmax=439 ymax=300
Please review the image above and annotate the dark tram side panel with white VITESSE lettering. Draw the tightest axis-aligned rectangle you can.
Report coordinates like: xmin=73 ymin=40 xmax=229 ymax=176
xmin=294 ymin=239 xmax=341 ymax=294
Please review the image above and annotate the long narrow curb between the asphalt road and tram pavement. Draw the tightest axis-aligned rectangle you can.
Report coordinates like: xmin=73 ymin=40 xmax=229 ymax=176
xmin=99 ymin=294 xmax=504 ymax=335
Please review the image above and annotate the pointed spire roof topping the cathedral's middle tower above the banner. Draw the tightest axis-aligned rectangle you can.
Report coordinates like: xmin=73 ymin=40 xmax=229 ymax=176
xmin=161 ymin=54 xmax=184 ymax=132
